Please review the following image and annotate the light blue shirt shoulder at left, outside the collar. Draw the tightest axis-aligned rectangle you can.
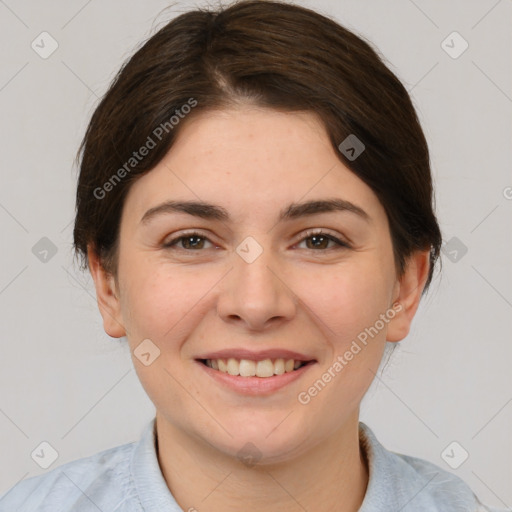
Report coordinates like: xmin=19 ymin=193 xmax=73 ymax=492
xmin=0 ymin=442 xmax=136 ymax=512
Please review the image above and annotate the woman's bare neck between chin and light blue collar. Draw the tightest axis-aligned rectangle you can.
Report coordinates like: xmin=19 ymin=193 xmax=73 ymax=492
xmin=157 ymin=413 xmax=368 ymax=512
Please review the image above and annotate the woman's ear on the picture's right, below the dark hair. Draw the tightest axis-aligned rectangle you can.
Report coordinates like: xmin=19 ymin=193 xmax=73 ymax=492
xmin=386 ymin=249 xmax=430 ymax=341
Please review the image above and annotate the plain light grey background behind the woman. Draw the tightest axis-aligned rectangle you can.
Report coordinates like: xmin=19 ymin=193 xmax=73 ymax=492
xmin=0 ymin=0 xmax=512 ymax=507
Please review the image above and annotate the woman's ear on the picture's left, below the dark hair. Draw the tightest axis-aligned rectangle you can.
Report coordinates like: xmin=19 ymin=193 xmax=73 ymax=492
xmin=87 ymin=245 xmax=126 ymax=338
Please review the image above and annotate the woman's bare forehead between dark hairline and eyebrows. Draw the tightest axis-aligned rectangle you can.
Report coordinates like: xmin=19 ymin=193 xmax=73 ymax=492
xmin=120 ymin=108 xmax=383 ymax=224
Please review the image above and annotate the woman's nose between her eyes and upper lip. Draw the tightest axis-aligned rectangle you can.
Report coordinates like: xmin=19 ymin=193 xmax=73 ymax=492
xmin=217 ymin=244 xmax=298 ymax=331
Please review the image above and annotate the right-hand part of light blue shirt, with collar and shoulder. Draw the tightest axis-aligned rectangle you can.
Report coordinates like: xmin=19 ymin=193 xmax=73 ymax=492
xmin=360 ymin=423 xmax=510 ymax=512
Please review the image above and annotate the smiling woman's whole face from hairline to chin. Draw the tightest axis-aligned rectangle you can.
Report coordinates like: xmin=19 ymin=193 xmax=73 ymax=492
xmin=91 ymin=107 xmax=424 ymax=462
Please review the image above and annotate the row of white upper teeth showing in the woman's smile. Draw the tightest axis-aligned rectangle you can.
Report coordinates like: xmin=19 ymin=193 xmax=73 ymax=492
xmin=206 ymin=357 xmax=303 ymax=378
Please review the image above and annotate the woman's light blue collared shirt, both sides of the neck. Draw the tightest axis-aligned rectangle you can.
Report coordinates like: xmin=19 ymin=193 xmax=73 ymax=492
xmin=0 ymin=418 xmax=500 ymax=512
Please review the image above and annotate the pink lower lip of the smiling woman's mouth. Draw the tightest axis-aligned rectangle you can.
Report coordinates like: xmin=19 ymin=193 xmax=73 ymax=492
xmin=196 ymin=361 xmax=314 ymax=395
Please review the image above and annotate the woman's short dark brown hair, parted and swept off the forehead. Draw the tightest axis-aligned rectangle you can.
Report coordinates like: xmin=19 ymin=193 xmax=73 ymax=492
xmin=73 ymin=0 xmax=441 ymax=291
